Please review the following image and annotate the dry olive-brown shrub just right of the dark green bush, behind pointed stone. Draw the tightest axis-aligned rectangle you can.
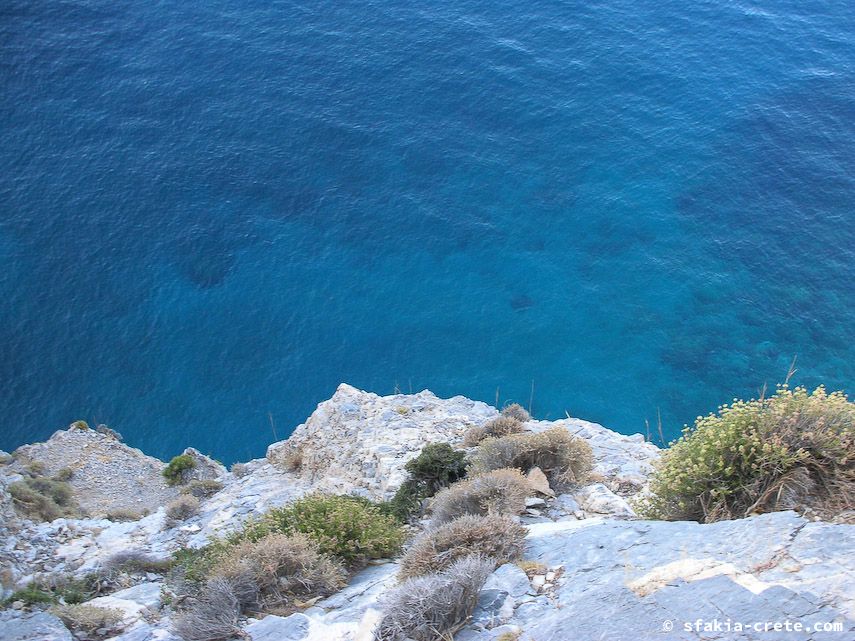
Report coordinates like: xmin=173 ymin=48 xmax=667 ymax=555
xmin=464 ymin=427 xmax=593 ymax=489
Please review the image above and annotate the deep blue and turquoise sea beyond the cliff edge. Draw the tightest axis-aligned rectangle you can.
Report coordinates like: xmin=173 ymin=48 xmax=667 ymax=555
xmin=0 ymin=0 xmax=855 ymax=462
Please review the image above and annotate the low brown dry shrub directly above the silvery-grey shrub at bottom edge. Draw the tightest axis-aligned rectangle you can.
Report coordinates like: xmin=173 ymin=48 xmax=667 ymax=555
xmin=399 ymin=514 xmax=526 ymax=579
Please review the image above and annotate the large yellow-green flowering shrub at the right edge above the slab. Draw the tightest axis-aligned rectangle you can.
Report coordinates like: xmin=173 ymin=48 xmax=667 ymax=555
xmin=639 ymin=386 xmax=855 ymax=522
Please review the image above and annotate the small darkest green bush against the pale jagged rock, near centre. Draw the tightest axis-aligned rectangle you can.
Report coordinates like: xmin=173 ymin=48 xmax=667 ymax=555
xmin=389 ymin=443 xmax=467 ymax=522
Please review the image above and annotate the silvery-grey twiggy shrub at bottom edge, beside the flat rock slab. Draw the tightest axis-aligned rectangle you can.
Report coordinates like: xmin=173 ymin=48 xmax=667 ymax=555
xmin=374 ymin=555 xmax=495 ymax=641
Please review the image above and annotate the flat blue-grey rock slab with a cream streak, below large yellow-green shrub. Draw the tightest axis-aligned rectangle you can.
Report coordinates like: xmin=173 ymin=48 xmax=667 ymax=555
xmin=509 ymin=512 xmax=855 ymax=641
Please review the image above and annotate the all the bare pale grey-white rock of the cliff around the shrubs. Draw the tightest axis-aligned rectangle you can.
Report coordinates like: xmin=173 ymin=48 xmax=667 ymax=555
xmin=0 ymin=385 xmax=855 ymax=641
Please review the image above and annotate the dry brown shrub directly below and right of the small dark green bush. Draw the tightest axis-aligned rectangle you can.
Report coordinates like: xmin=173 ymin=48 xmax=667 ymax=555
xmin=431 ymin=468 xmax=532 ymax=525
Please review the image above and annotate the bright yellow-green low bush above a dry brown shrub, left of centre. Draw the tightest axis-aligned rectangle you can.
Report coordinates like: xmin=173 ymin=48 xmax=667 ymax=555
xmin=238 ymin=494 xmax=404 ymax=564
